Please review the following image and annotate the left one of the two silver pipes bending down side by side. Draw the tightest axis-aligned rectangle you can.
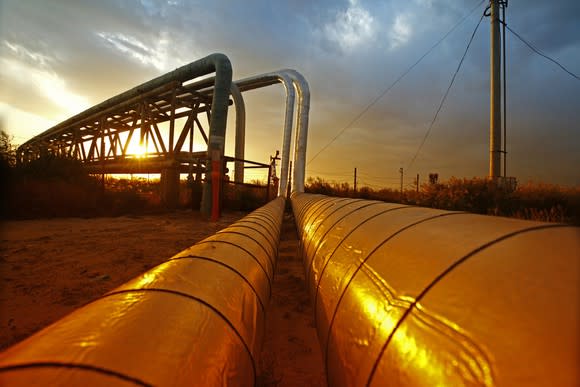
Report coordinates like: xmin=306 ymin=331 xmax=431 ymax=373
xmin=235 ymin=70 xmax=295 ymax=197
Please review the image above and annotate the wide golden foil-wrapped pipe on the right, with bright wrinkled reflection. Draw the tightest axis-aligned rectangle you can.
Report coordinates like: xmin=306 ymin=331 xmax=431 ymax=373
xmin=292 ymin=194 xmax=580 ymax=386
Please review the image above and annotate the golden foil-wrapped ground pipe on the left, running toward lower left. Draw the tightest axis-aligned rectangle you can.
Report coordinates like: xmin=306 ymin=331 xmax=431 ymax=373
xmin=0 ymin=198 xmax=284 ymax=386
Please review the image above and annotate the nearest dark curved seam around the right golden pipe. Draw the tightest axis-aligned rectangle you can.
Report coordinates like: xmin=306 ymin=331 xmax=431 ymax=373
xmin=368 ymin=224 xmax=570 ymax=386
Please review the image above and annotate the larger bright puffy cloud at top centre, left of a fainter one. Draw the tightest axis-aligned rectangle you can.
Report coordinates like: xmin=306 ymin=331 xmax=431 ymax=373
xmin=324 ymin=0 xmax=376 ymax=51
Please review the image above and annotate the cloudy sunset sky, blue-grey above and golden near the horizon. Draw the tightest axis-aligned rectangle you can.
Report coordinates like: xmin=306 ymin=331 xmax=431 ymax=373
xmin=0 ymin=0 xmax=580 ymax=188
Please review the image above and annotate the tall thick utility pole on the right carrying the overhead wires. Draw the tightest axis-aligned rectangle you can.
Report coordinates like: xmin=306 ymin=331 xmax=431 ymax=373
xmin=489 ymin=0 xmax=502 ymax=180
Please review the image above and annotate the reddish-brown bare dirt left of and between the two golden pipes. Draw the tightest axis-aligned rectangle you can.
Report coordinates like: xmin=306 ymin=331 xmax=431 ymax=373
xmin=0 ymin=211 xmax=325 ymax=386
